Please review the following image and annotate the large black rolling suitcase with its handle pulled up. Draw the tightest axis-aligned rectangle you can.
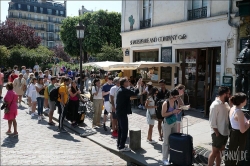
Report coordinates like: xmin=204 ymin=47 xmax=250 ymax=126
xmin=169 ymin=118 xmax=194 ymax=166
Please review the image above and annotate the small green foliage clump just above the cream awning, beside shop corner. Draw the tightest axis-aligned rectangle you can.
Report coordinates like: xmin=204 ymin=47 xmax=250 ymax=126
xmin=96 ymin=44 xmax=123 ymax=62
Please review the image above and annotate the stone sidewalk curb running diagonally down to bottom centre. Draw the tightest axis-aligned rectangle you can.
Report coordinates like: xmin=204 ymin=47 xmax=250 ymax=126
xmin=44 ymin=112 xmax=148 ymax=165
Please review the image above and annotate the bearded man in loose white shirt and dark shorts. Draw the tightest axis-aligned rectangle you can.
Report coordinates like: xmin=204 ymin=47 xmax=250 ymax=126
xmin=208 ymin=86 xmax=230 ymax=166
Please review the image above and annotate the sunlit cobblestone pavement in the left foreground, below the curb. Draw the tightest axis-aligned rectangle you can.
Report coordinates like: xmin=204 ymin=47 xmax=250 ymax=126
xmin=1 ymin=91 xmax=127 ymax=165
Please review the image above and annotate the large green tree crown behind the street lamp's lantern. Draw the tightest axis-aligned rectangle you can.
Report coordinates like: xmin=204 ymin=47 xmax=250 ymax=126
xmin=60 ymin=10 xmax=121 ymax=56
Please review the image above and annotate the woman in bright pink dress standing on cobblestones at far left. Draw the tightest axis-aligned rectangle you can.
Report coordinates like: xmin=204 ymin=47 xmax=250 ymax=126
xmin=3 ymin=82 xmax=18 ymax=135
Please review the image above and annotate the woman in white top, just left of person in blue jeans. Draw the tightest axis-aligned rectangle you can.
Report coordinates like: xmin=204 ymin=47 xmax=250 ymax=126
xmin=28 ymin=77 xmax=37 ymax=117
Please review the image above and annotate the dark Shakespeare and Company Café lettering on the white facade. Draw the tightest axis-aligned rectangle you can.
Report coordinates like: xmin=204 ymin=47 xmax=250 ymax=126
xmin=130 ymin=34 xmax=187 ymax=45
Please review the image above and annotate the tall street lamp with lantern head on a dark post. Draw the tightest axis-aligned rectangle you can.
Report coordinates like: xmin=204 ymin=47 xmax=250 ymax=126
xmin=76 ymin=21 xmax=85 ymax=93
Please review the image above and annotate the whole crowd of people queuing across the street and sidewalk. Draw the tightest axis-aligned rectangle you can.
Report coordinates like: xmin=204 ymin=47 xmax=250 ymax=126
xmin=0 ymin=64 xmax=250 ymax=166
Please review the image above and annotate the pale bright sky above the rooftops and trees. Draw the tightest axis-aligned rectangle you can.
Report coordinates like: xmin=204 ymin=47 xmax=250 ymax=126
xmin=0 ymin=0 xmax=122 ymax=22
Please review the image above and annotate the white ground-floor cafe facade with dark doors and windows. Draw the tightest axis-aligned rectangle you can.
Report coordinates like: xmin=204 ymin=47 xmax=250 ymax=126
xmin=121 ymin=16 xmax=238 ymax=113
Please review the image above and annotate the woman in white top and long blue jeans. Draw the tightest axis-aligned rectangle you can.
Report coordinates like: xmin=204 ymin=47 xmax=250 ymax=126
xmin=36 ymin=78 xmax=45 ymax=121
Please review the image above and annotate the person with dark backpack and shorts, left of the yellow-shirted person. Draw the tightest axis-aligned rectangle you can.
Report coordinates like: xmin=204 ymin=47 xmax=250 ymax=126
xmin=48 ymin=76 xmax=59 ymax=126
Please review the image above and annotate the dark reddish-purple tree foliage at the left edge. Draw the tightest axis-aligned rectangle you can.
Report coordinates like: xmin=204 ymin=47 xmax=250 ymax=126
xmin=0 ymin=20 xmax=41 ymax=48
